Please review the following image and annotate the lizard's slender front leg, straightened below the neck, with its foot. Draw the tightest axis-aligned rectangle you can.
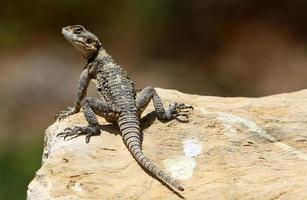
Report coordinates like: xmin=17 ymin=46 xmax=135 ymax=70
xmin=56 ymin=68 xmax=91 ymax=120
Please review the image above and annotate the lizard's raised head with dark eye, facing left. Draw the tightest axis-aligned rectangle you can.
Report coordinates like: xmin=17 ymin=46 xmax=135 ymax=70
xmin=62 ymin=25 xmax=101 ymax=59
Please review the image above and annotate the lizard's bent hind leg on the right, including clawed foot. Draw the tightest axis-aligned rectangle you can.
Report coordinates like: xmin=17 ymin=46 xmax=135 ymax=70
xmin=136 ymin=87 xmax=193 ymax=122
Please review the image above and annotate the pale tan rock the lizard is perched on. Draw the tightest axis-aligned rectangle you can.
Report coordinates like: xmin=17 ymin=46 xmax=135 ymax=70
xmin=28 ymin=89 xmax=307 ymax=200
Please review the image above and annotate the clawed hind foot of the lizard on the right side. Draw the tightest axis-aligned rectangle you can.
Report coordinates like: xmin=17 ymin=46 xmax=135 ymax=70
xmin=166 ymin=103 xmax=194 ymax=122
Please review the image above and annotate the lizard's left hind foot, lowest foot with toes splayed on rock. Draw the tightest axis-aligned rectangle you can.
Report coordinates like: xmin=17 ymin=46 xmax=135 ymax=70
xmin=57 ymin=125 xmax=101 ymax=143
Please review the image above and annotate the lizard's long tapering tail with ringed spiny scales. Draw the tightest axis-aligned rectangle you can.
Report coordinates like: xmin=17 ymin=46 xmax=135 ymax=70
xmin=118 ymin=113 xmax=184 ymax=191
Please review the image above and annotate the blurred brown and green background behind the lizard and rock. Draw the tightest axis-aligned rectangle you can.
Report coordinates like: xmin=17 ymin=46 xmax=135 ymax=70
xmin=0 ymin=0 xmax=307 ymax=199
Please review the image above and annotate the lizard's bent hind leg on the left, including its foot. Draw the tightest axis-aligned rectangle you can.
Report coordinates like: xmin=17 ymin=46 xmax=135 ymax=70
xmin=57 ymin=97 xmax=119 ymax=143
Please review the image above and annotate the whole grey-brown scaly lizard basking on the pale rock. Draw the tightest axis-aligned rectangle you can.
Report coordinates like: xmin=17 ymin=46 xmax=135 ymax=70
xmin=56 ymin=25 xmax=194 ymax=191
